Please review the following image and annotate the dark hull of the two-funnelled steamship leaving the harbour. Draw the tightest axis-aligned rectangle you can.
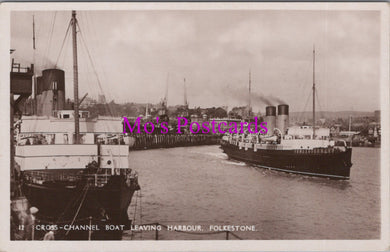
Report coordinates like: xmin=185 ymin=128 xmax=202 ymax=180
xmin=221 ymin=142 xmax=352 ymax=179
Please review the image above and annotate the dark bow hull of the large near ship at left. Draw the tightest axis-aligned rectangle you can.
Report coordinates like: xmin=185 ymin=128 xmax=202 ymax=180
xmin=22 ymin=171 xmax=139 ymax=240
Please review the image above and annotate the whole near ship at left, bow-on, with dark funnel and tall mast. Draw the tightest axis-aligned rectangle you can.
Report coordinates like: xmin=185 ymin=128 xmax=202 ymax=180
xmin=11 ymin=11 xmax=140 ymax=240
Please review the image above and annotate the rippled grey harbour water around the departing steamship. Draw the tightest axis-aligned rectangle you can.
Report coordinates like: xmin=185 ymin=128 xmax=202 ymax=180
xmin=123 ymin=145 xmax=380 ymax=240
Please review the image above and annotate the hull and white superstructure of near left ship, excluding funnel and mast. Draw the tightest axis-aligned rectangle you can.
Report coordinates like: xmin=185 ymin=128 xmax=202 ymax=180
xmin=15 ymin=111 xmax=140 ymax=239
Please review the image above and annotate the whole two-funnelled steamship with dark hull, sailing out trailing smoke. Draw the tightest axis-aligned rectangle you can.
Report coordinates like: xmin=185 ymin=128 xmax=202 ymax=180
xmin=221 ymin=50 xmax=352 ymax=179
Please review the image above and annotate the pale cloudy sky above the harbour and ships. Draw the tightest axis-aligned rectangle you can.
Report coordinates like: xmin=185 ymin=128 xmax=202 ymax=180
xmin=11 ymin=10 xmax=380 ymax=111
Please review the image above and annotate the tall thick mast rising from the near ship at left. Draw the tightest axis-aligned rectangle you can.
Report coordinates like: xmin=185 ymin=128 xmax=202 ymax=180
xmin=71 ymin=11 xmax=80 ymax=144
